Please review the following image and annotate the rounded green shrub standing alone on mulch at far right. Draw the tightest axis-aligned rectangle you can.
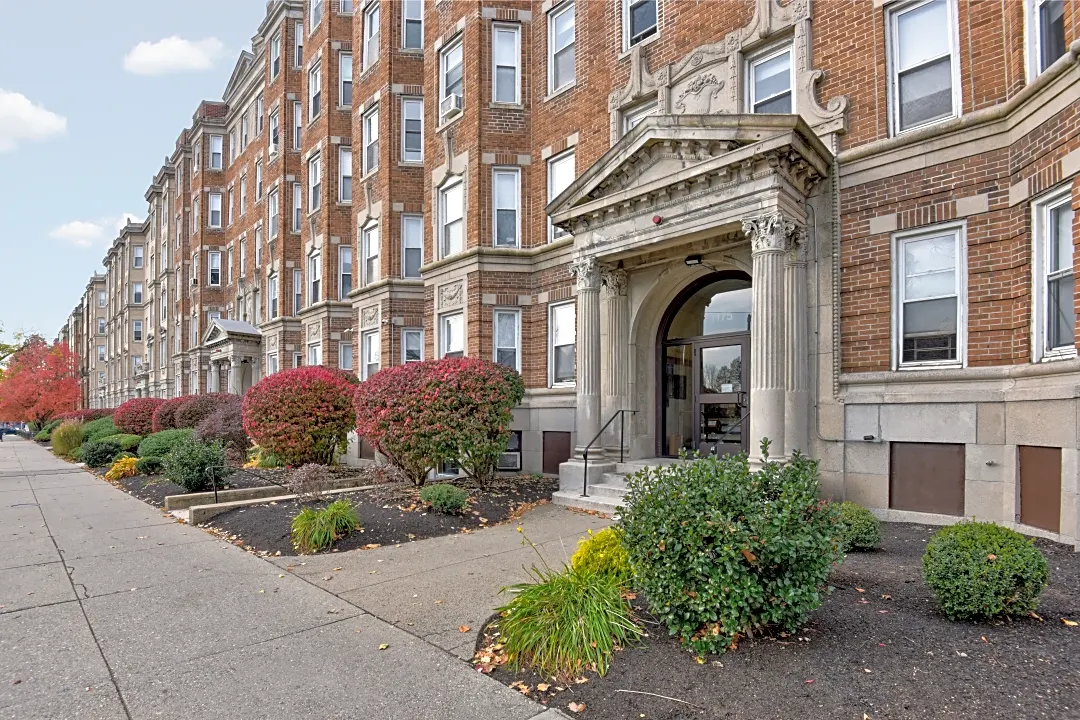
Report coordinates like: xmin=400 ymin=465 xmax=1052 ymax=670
xmin=922 ymin=522 xmax=1048 ymax=620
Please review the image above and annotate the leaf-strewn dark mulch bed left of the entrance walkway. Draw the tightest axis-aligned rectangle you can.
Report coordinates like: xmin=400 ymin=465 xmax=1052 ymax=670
xmin=207 ymin=475 xmax=558 ymax=555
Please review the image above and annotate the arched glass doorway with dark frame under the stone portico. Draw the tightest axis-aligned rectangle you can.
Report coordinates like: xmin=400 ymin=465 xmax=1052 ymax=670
xmin=657 ymin=271 xmax=752 ymax=457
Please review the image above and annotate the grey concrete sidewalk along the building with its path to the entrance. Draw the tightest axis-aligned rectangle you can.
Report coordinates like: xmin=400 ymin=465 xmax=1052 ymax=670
xmin=0 ymin=438 xmax=574 ymax=720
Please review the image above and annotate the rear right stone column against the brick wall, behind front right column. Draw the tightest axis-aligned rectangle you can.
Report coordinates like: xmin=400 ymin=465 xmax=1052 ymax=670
xmin=784 ymin=228 xmax=810 ymax=457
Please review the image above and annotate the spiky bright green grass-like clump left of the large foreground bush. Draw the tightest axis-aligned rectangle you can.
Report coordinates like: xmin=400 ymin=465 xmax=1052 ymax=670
xmin=498 ymin=567 xmax=642 ymax=679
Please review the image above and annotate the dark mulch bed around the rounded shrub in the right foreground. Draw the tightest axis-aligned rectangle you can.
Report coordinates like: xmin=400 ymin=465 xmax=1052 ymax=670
xmin=480 ymin=524 xmax=1080 ymax=720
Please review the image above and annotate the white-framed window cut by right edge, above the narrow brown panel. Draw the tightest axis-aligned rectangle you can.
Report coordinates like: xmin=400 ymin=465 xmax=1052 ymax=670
xmin=1031 ymin=186 xmax=1077 ymax=362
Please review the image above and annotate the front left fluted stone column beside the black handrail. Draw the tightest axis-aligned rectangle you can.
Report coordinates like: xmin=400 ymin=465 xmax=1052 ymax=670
xmin=570 ymin=256 xmax=604 ymax=460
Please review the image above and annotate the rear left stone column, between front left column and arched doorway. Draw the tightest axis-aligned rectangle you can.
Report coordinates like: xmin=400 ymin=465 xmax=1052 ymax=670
xmin=600 ymin=267 xmax=633 ymax=458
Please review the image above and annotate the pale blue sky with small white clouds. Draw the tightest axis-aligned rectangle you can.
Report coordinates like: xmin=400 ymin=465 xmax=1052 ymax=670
xmin=0 ymin=0 xmax=266 ymax=339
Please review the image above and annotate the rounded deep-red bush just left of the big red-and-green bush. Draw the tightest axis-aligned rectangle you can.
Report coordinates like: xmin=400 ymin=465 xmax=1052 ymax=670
xmin=243 ymin=366 xmax=354 ymax=465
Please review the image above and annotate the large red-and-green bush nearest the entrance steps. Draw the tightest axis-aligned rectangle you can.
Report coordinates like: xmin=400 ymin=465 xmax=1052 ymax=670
xmin=355 ymin=357 xmax=525 ymax=485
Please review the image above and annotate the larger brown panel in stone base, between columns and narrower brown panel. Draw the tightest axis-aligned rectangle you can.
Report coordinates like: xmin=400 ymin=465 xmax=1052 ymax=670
xmin=889 ymin=443 xmax=964 ymax=515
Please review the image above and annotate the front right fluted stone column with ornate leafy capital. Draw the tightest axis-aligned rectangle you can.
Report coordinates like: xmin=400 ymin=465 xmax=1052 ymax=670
xmin=743 ymin=212 xmax=795 ymax=463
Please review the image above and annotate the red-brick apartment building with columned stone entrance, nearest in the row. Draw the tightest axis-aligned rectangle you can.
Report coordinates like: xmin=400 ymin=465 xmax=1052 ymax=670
xmin=59 ymin=0 xmax=1080 ymax=542
